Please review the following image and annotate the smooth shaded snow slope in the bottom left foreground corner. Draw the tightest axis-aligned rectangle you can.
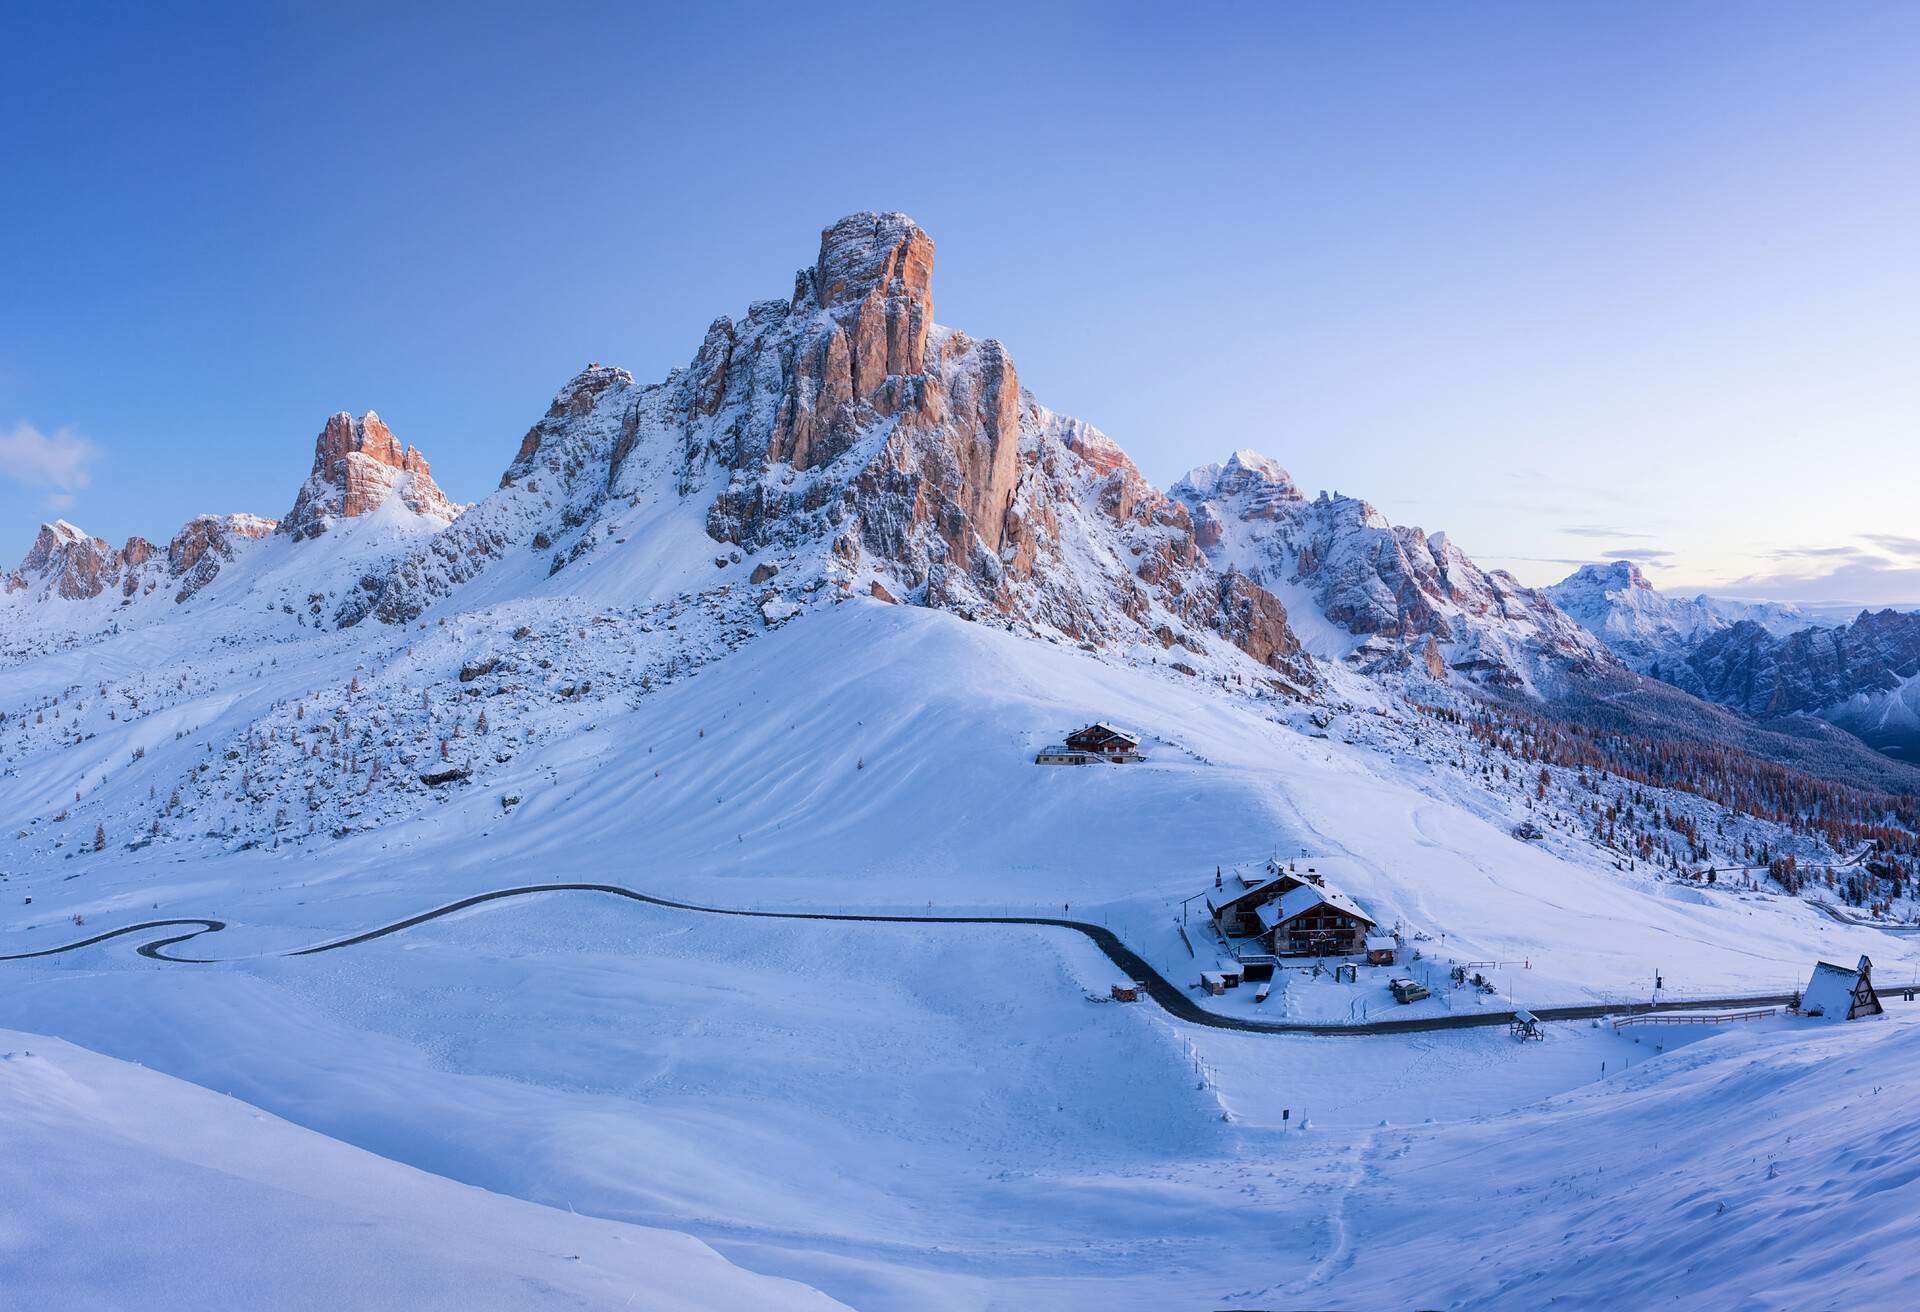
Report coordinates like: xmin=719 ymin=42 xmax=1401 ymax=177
xmin=0 ymin=1032 xmax=841 ymax=1312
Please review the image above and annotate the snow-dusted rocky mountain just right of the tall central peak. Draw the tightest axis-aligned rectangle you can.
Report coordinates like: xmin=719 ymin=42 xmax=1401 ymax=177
xmin=1173 ymin=451 xmax=1617 ymax=695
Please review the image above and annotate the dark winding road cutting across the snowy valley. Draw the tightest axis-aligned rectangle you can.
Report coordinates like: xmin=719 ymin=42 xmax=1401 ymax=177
xmin=0 ymin=884 xmax=1901 ymax=1035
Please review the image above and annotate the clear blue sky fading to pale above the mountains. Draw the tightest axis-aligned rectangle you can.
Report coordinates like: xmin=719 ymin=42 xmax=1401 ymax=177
xmin=0 ymin=2 xmax=1920 ymax=603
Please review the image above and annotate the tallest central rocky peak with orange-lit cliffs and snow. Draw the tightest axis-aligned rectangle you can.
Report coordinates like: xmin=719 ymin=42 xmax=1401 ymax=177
xmin=340 ymin=213 xmax=1308 ymax=678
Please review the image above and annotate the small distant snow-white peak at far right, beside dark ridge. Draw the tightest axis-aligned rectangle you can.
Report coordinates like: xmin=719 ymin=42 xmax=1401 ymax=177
xmin=1546 ymin=561 xmax=1814 ymax=695
